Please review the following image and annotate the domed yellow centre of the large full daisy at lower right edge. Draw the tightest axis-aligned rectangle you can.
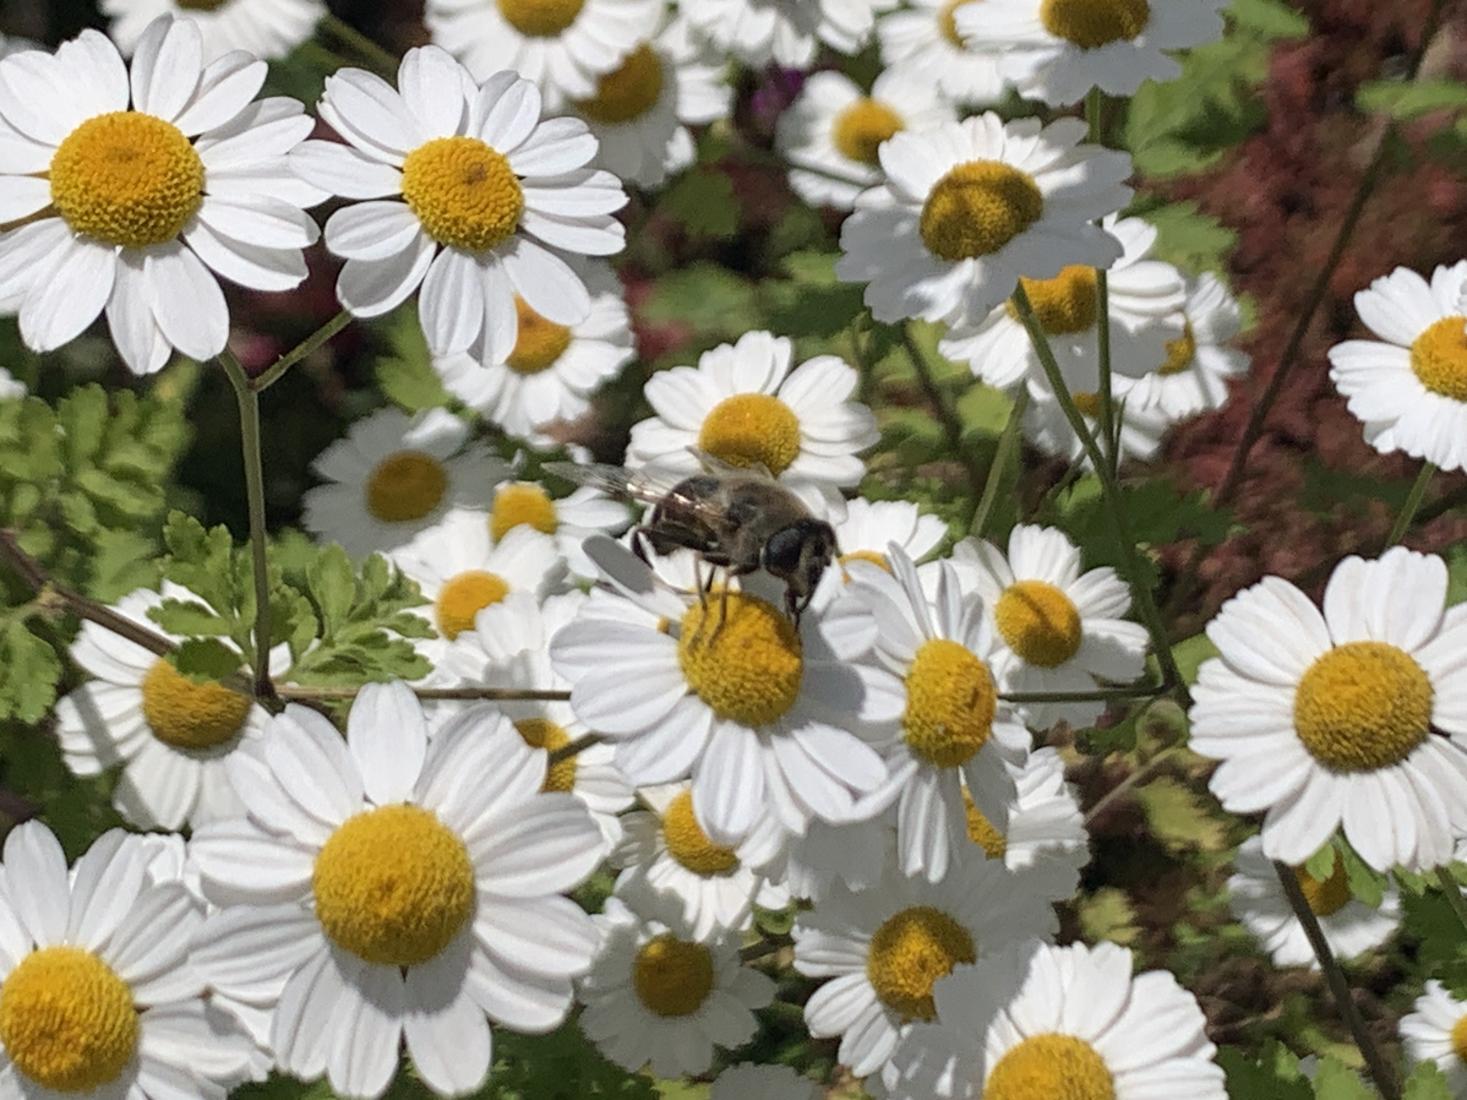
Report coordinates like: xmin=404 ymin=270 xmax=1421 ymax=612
xmin=1294 ymin=642 xmax=1435 ymax=771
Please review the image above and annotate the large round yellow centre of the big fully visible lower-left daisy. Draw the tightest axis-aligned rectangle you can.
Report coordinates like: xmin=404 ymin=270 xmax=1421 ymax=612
xmin=311 ymin=804 xmax=474 ymax=967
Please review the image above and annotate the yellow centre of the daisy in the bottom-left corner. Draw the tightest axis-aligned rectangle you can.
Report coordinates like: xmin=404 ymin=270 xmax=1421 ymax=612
xmin=0 ymin=950 xmax=138 ymax=1093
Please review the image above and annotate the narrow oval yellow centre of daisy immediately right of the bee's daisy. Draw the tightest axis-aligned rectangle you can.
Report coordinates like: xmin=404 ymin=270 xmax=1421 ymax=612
xmin=902 ymin=638 xmax=998 ymax=767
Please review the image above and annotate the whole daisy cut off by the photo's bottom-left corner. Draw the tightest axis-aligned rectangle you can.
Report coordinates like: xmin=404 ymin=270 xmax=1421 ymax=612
xmin=0 ymin=821 xmax=254 ymax=1100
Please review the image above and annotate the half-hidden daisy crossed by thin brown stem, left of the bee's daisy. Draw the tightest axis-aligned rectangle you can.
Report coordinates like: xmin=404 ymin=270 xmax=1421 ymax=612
xmin=445 ymin=591 xmax=634 ymax=854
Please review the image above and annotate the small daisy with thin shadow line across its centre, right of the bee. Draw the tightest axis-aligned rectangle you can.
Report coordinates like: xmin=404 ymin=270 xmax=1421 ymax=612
xmin=952 ymin=524 xmax=1147 ymax=729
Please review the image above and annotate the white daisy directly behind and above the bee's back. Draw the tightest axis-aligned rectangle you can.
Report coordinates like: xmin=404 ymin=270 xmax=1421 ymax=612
xmin=626 ymin=331 xmax=879 ymax=509
